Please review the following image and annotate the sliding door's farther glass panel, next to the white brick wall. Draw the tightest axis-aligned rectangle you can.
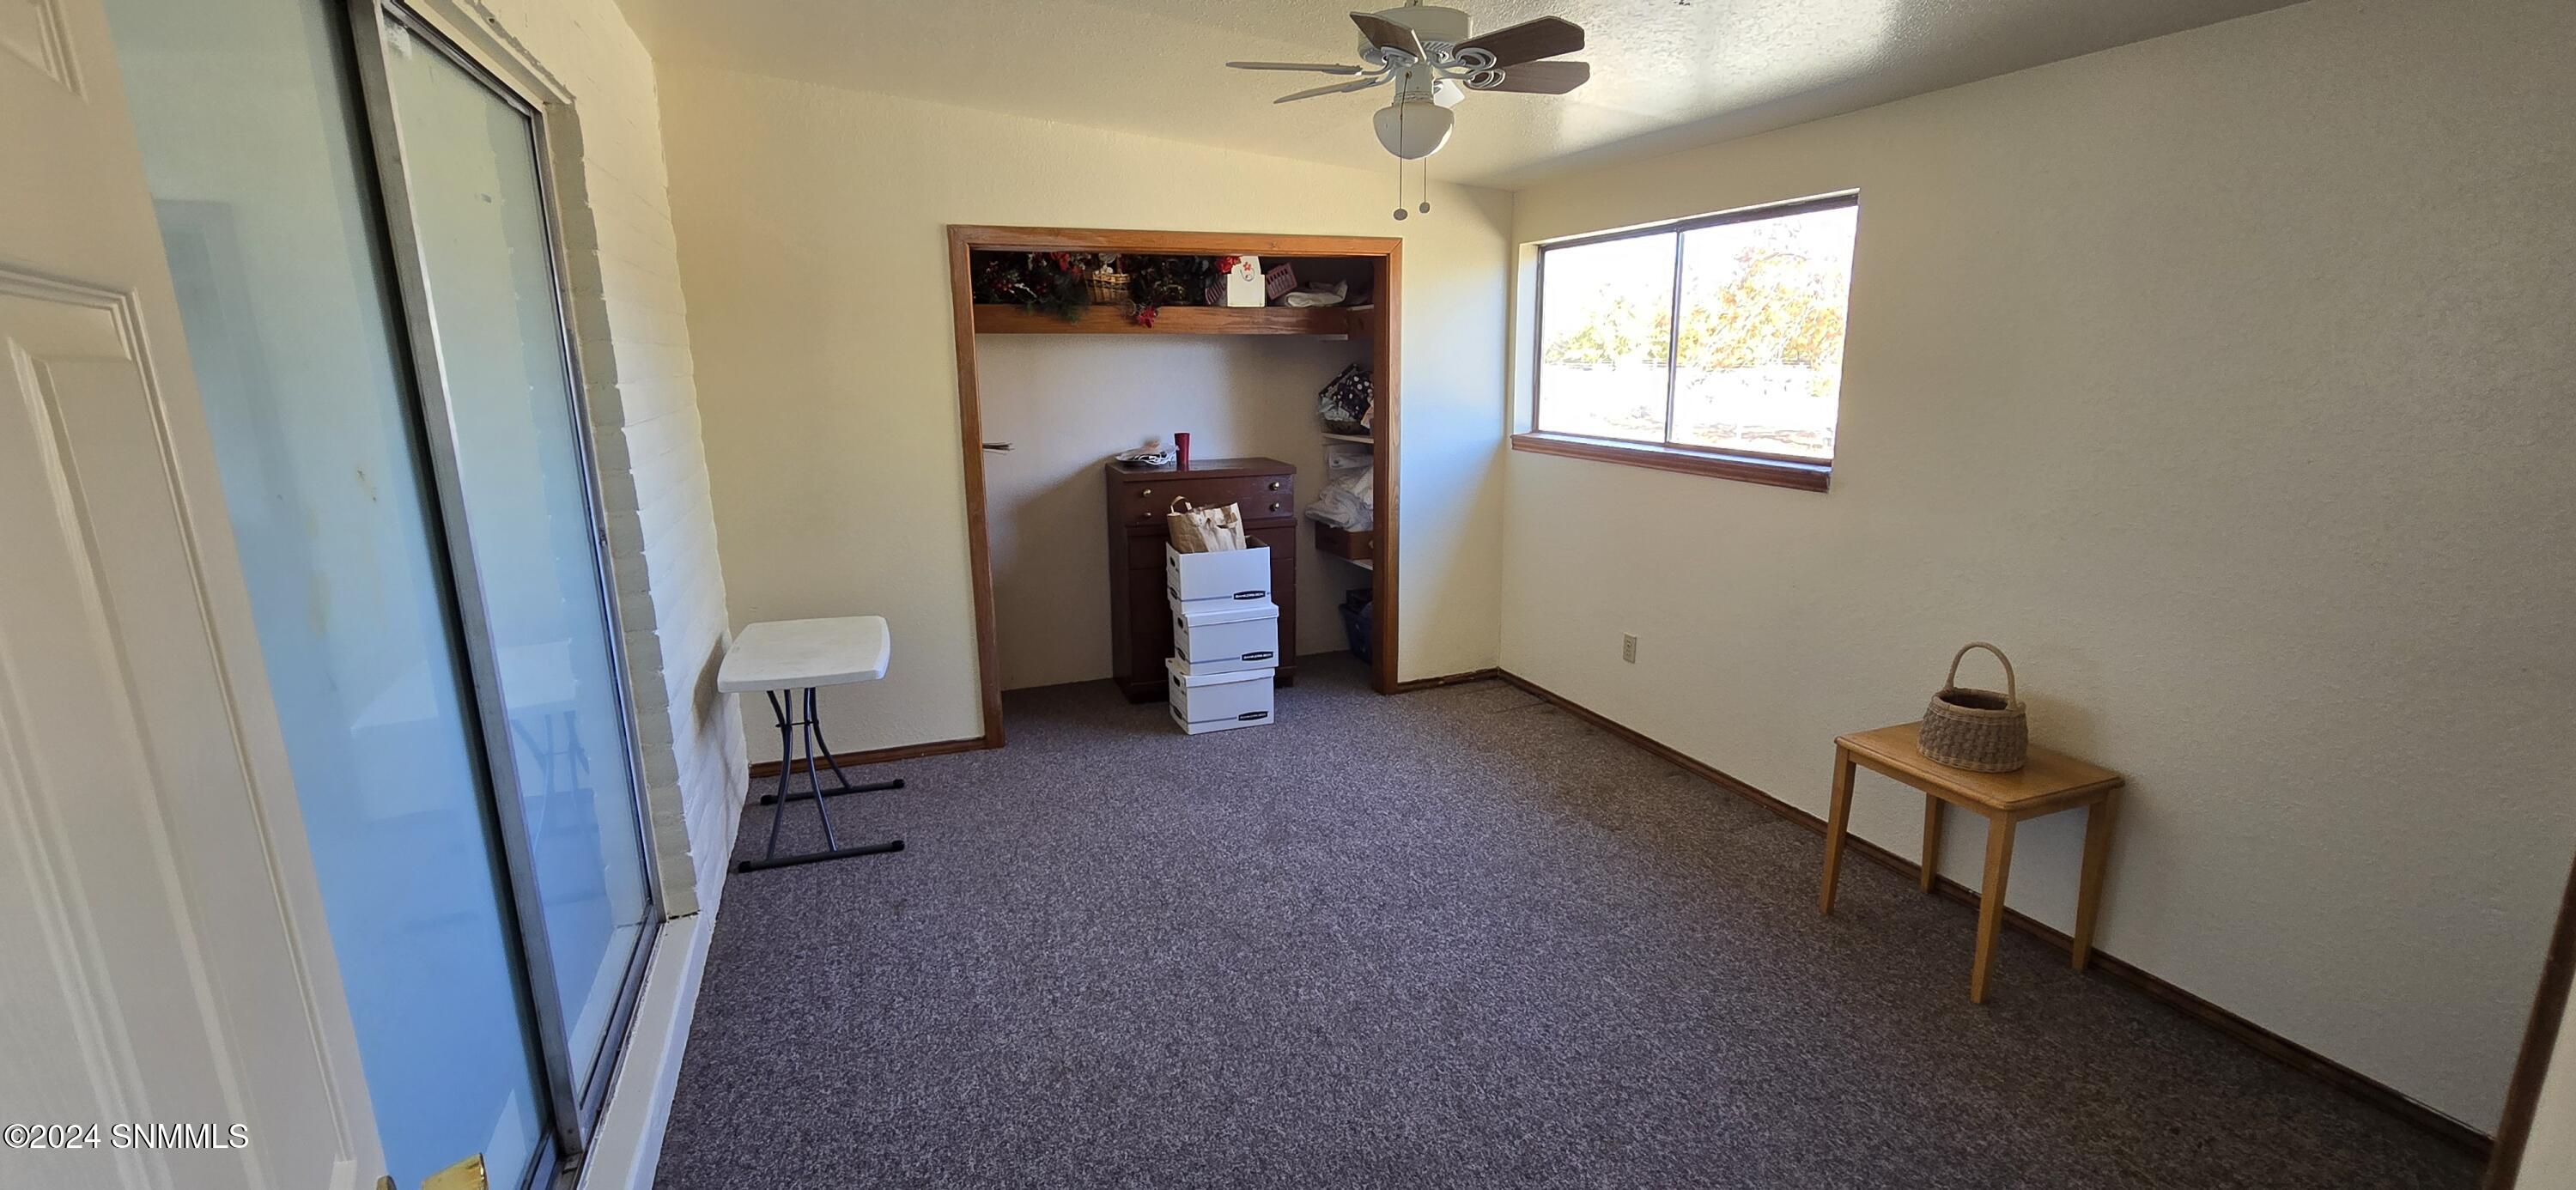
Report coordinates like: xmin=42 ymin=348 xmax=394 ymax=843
xmin=386 ymin=18 xmax=647 ymax=1092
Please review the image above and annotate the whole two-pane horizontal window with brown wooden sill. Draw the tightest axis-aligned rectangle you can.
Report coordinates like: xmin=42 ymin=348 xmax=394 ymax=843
xmin=1512 ymin=196 xmax=1860 ymax=492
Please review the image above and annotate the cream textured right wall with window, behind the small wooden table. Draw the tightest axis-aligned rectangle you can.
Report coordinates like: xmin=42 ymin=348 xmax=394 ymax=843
xmin=1502 ymin=0 xmax=2576 ymax=1128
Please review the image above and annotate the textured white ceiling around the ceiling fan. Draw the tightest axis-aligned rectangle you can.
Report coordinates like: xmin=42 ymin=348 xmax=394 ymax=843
xmin=621 ymin=0 xmax=2287 ymax=188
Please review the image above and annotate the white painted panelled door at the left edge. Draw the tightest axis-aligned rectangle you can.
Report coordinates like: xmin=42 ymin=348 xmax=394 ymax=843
xmin=0 ymin=0 xmax=379 ymax=1190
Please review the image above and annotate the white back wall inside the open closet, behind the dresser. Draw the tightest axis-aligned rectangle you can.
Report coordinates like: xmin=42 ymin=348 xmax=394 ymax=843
xmin=976 ymin=335 xmax=1381 ymax=690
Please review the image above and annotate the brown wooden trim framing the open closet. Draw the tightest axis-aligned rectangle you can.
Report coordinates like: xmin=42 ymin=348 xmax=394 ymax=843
xmin=948 ymin=224 xmax=1404 ymax=747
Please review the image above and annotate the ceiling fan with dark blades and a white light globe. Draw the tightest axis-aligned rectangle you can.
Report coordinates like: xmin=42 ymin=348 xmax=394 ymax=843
xmin=1226 ymin=0 xmax=1592 ymax=219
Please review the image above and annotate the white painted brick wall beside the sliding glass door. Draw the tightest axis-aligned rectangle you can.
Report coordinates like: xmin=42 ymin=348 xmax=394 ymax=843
xmin=433 ymin=0 xmax=744 ymax=917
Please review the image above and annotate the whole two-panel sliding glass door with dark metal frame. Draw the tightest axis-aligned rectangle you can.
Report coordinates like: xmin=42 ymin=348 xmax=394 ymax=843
xmin=108 ymin=0 xmax=657 ymax=1187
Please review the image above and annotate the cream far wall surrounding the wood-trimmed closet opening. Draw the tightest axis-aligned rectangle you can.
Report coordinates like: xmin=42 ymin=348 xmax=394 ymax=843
xmin=662 ymin=64 xmax=1510 ymax=757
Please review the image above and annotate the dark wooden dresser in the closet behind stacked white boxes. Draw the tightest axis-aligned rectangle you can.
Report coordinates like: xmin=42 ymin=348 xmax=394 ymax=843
xmin=1103 ymin=458 xmax=1296 ymax=703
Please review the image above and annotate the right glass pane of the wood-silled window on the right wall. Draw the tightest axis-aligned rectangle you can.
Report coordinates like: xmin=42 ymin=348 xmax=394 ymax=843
xmin=1672 ymin=206 xmax=1860 ymax=458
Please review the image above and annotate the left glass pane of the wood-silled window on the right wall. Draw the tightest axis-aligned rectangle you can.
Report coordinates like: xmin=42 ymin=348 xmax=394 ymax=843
xmin=1538 ymin=232 xmax=1674 ymax=443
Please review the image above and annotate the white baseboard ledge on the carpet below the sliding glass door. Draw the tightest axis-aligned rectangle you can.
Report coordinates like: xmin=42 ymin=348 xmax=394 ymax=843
xmin=577 ymin=907 xmax=716 ymax=1190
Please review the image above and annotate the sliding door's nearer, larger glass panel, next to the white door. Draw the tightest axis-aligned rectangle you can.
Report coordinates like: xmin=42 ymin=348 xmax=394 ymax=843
xmin=108 ymin=0 xmax=544 ymax=1185
